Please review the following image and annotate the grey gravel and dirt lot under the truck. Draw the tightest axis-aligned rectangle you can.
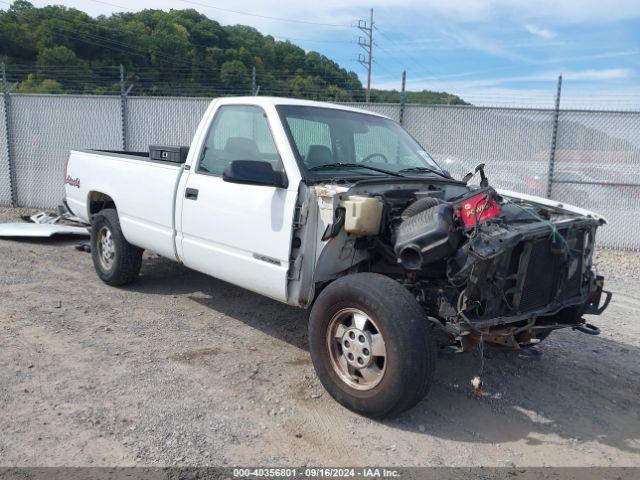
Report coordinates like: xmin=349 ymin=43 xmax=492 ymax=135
xmin=0 ymin=209 xmax=640 ymax=466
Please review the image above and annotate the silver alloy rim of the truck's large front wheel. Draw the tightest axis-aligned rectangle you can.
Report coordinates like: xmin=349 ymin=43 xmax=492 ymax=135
xmin=326 ymin=308 xmax=387 ymax=390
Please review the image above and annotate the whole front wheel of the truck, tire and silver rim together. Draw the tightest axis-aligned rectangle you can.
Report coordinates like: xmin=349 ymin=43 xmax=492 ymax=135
xmin=309 ymin=273 xmax=436 ymax=418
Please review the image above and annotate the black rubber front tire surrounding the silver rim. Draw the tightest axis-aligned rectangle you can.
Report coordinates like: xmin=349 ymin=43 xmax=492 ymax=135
xmin=309 ymin=273 xmax=436 ymax=418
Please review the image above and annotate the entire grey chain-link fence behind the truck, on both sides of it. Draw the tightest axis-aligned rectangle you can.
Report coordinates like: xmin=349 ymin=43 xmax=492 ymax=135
xmin=0 ymin=95 xmax=640 ymax=250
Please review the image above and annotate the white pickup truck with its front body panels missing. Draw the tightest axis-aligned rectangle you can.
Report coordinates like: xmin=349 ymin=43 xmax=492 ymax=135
xmin=65 ymin=97 xmax=610 ymax=417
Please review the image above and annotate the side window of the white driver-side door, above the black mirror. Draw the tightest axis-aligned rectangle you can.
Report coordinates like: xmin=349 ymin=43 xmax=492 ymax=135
xmin=196 ymin=105 xmax=282 ymax=175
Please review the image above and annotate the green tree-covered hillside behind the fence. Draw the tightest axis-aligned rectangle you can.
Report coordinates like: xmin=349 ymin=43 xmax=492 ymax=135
xmin=0 ymin=0 xmax=462 ymax=103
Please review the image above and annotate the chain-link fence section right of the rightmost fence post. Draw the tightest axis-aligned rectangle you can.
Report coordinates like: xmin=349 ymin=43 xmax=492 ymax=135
xmin=551 ymin=111 xmax=640 ymax=250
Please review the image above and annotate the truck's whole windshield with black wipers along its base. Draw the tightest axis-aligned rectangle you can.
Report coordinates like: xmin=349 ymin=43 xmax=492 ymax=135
xmin=277 ymin=105 xmax=442 ymax=179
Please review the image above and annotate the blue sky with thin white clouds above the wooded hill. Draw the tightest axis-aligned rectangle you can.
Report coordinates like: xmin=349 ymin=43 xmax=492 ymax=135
xmin=33 ymin=0 xmax=640 ymax=108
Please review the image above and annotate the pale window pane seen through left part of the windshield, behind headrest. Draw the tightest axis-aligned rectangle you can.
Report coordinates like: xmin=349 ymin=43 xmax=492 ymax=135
xmin=287 ymin=118 xmax=334 ymax=168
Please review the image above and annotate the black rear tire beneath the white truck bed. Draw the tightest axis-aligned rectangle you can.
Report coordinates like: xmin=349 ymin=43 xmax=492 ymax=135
xmin=91 ymin=208 xmax=143 ymax=286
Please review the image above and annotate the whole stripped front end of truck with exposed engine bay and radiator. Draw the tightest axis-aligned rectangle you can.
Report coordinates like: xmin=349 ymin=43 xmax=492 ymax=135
xmin=308 ymin=167 xmax=611 ymax=351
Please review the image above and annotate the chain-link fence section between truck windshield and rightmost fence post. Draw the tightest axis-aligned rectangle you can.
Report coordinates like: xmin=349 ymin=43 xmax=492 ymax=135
xmin=404 ymin=107 xmax=553 ymax=196
